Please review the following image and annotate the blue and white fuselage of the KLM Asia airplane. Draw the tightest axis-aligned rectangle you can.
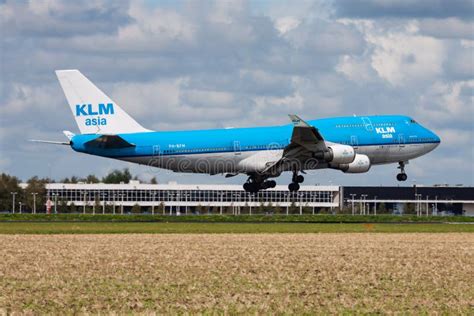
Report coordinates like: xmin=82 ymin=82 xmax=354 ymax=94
xmin=72 ymin=115 xmax=440 ymax=174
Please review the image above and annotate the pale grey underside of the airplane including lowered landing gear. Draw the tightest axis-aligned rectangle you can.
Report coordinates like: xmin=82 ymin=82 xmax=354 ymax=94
xmin=121 ymin=144 xmax=434 ymax=191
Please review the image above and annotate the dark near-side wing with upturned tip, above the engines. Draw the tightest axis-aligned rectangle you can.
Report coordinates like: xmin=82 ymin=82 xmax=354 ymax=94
xmin=263 ymin=114 xmax=328 ymax=173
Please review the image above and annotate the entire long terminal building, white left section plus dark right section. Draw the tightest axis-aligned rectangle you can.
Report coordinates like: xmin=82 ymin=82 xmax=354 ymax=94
xmin=41 ymin=181 xmax=474 ymax=216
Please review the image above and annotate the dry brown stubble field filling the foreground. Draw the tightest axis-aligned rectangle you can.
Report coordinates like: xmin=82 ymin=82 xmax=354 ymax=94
xmin=0 ymin=233 xmax=474 ymax=315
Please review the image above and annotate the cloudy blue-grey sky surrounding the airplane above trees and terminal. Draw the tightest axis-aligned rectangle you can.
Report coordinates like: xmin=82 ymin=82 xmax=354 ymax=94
xmin=0 ymin=0 xmax=474 ymax=185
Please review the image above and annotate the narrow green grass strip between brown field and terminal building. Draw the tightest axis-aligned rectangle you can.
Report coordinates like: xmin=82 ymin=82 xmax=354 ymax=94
xmin=0 ymin=222 xmax=474 ymax=234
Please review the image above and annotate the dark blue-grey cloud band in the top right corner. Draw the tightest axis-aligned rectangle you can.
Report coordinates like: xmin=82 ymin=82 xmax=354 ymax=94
xmin=334 ymin=0 xmax=474 ymax=18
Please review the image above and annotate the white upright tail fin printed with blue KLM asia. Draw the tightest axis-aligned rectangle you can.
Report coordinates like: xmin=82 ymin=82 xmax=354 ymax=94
xmin=56 ymin=70 xmax=150 ymax=134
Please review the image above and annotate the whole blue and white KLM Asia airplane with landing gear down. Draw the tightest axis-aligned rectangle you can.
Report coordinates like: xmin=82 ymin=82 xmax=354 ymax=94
xmin=32 ymin=70 xmax=441 ymax=193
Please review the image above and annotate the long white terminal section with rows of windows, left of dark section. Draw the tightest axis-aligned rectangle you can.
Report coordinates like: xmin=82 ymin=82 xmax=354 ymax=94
xmin=46 ymin=181 xmax=343 ymax=214
